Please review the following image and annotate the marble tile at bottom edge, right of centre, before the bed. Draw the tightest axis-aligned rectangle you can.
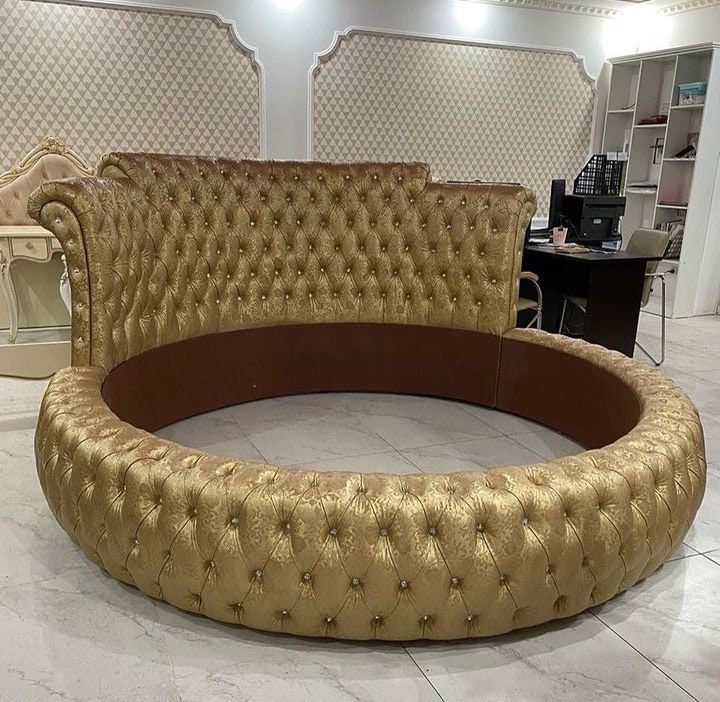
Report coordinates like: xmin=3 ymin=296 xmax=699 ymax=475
xmin=406 ymin=614 xmax=692 ymax=702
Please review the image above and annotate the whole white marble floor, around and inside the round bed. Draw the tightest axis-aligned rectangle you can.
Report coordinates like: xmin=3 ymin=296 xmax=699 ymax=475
xmin=0 ymin=316 xmax=720 ymax=702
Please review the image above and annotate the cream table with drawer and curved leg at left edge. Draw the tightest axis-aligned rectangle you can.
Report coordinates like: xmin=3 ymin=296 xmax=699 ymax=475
xmin=0 ymin=225 xmax=62 ymax=344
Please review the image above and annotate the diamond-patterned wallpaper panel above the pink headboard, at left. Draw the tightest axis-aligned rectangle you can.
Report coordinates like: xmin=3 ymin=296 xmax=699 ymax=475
xmin=0 ymin=0 xmax=260 ymax=171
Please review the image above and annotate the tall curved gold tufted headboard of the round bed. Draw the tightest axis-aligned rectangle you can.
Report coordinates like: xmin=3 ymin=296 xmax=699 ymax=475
xmin=29 ymin=153 xmax=535 ymax=370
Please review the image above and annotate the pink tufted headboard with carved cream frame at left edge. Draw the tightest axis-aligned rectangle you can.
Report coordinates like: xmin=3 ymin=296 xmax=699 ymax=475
xmin=0 ymin=137 xmax=93 ymax=226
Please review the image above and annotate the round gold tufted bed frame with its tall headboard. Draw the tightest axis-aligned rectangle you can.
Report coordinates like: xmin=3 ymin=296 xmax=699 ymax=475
xmin=30 ymin=154 xmax=705 ymax=640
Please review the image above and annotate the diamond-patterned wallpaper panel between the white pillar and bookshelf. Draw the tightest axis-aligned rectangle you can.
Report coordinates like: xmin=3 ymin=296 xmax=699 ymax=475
xmin=313 ymin=32 xmax=594 ymax=213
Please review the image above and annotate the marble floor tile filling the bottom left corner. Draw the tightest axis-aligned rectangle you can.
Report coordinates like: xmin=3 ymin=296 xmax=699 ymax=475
xmin=0 ymin=563 xmax=174 ymax=702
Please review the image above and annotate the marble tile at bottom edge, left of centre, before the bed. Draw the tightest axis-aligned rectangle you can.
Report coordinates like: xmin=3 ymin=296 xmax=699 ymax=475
xmin=158 ymin=603 xmax=441 ymax=702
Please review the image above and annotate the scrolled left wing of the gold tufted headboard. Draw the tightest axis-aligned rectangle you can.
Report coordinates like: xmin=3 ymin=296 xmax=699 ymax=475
xmin=28 ymin=178 xmax=159 ymax=370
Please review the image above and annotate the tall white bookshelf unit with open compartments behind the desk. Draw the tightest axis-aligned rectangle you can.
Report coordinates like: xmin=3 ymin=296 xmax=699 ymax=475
xmin=603 ymin=43 xmax=720 ymax=317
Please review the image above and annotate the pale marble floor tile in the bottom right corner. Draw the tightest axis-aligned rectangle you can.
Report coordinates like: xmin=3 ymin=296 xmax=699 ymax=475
xmin=594 ymin=556 xmax=720 ymax=702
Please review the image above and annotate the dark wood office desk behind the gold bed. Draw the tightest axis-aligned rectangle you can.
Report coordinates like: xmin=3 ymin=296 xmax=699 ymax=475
xmin=522 ymin=244 xmax=660 ymax=357
